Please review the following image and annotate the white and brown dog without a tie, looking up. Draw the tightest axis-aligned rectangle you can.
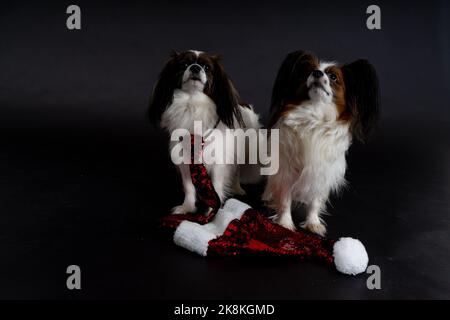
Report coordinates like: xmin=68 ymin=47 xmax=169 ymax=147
xmin=263 ymin=51 xmax=379 ymax=235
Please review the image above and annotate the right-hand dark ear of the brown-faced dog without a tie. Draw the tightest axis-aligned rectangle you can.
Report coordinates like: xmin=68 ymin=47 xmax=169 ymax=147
xmin=341 ymin=59 xmax=380 ymax=142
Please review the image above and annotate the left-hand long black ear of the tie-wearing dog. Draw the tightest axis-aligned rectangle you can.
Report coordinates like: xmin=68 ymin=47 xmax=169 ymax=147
xmin=147 ymin=51 xmax=180 ymax=125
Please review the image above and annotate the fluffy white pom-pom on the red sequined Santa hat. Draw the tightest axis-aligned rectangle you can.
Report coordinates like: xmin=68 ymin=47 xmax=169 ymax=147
xmin=333 ymin=238 xmax=369 ymax=275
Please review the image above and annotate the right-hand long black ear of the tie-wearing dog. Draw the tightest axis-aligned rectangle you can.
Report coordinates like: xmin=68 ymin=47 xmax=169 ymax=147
xmin=210 ymin=56 xmax=244 ymax=128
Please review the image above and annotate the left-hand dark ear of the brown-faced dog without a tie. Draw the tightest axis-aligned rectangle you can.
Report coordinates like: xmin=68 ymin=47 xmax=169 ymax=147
xmin=269 ymin=50 xmax=318 ymax=127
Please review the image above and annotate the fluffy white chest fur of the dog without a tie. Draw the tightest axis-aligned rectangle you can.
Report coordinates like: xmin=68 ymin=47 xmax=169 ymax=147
xmin=277 ymin=101 xmax=351 ymax=203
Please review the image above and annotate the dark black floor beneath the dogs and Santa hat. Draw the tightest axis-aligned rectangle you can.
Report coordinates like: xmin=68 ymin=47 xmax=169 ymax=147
xmin=0 ymin=119 xmax=450 ymax=299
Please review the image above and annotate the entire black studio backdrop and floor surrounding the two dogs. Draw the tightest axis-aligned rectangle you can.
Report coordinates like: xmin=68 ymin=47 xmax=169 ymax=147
xmin=0 ymin=1 xmax=450 ymax=299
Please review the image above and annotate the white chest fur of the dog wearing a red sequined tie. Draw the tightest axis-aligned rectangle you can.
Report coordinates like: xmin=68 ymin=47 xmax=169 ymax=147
xmin=161 ymin=89 xmax=217 ymax=133
